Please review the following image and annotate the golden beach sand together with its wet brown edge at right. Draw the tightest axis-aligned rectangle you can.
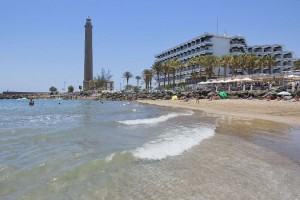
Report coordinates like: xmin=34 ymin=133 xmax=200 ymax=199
xmin=138 ymin=99 xmax=300 ymax=166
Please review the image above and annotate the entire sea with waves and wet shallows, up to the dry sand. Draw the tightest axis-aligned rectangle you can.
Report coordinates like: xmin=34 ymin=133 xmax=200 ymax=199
xmin=0 ymin=99 xmax=300 ymax=200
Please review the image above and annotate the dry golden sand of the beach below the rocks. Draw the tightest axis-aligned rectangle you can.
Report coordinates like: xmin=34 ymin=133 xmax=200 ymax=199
xmin=138 ymin=99 xmax=300 ymax=126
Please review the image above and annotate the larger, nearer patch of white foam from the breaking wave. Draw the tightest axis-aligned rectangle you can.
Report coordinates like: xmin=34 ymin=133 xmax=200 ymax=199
xmin=132 ymin=126 xmax=214 ymax=160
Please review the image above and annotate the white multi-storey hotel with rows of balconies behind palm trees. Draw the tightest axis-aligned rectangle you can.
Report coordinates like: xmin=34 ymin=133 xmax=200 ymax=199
xmin=155 ymin=33 xmax=294 ymax=84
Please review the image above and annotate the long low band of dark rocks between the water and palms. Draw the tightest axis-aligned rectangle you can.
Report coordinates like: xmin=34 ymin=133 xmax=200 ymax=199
xmin=0 ymin=88 xmax=300 ymax=101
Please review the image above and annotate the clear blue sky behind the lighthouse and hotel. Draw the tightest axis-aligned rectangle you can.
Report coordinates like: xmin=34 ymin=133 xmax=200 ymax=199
xmin=0 ymin=0 xmax=300 ymax=93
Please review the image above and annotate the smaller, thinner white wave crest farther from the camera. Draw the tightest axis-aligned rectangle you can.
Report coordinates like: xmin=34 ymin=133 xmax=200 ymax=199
xmin=118 ymin=111 xmax=193 ymax=125
